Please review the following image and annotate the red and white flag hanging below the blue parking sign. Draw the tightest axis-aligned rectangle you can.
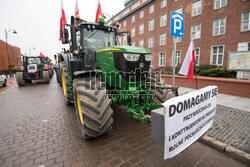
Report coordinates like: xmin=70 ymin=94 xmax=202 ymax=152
xmin=179 ymin=40 xmax=195 ymax=81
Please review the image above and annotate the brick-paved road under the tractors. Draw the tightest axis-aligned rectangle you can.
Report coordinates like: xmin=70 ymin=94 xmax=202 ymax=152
xmin=0 ymin=77 xmax=244 ymax=167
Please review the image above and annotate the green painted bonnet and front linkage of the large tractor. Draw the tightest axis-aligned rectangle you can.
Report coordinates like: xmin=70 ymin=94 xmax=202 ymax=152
xmin=64 ymin=20 xmax=163 ymax=122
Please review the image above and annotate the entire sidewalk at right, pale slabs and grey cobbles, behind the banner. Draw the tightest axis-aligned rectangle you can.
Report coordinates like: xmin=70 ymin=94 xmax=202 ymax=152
xmin=179 ymin=87 xmax=250 ymax=154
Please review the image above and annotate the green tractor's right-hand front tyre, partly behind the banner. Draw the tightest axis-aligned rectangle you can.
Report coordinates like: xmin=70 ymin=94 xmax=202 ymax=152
xmin=148 ymin=75 xmax=178 ymax=104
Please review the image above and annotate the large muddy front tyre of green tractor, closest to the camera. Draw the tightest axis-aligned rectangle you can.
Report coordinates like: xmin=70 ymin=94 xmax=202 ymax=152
xmin=73 ymin=77 xmax=113 ymax=139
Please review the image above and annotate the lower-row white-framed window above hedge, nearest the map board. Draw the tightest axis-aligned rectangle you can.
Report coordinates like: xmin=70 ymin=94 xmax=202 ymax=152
xmin=211 ymin=45 xmax=224 ymax=65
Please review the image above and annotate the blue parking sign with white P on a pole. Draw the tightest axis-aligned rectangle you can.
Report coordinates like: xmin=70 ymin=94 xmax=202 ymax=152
xmin=170 ymin=11 xmax=185 ymax=37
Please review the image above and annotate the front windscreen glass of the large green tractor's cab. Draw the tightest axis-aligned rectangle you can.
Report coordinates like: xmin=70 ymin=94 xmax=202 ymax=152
xmin=83 ymin=29 xmax=115 ymax=67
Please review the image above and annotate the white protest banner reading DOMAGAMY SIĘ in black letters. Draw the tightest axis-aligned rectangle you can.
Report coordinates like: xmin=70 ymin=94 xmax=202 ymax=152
xmin=163 ymin=86 xmax=218 ymax=159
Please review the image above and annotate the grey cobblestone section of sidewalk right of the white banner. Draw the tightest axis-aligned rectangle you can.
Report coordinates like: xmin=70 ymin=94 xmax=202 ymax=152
xmin=207 ymin=105 xmax=250 ymax=153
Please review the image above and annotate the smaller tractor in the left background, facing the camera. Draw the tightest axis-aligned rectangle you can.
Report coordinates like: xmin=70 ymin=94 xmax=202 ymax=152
xmin=16 ymin=55 xmax=50 ymax=86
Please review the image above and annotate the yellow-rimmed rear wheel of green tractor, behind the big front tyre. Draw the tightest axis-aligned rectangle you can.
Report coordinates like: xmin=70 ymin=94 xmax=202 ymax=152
xmin=60 ymin=62 xmax=73 ymax=105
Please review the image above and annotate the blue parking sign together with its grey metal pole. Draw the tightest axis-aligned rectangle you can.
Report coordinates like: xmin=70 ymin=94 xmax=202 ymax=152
xmin=170 ymin=11 xmax=184 ymax=87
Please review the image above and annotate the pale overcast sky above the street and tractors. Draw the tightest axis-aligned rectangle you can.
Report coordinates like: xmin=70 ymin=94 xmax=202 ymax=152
xmin=0 ymin=0 xmax=124 ymax=58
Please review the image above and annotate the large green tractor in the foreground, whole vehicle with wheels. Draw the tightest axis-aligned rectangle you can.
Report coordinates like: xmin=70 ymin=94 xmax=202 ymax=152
xmin=60 ymin=16 xmax=178 ymax=139
